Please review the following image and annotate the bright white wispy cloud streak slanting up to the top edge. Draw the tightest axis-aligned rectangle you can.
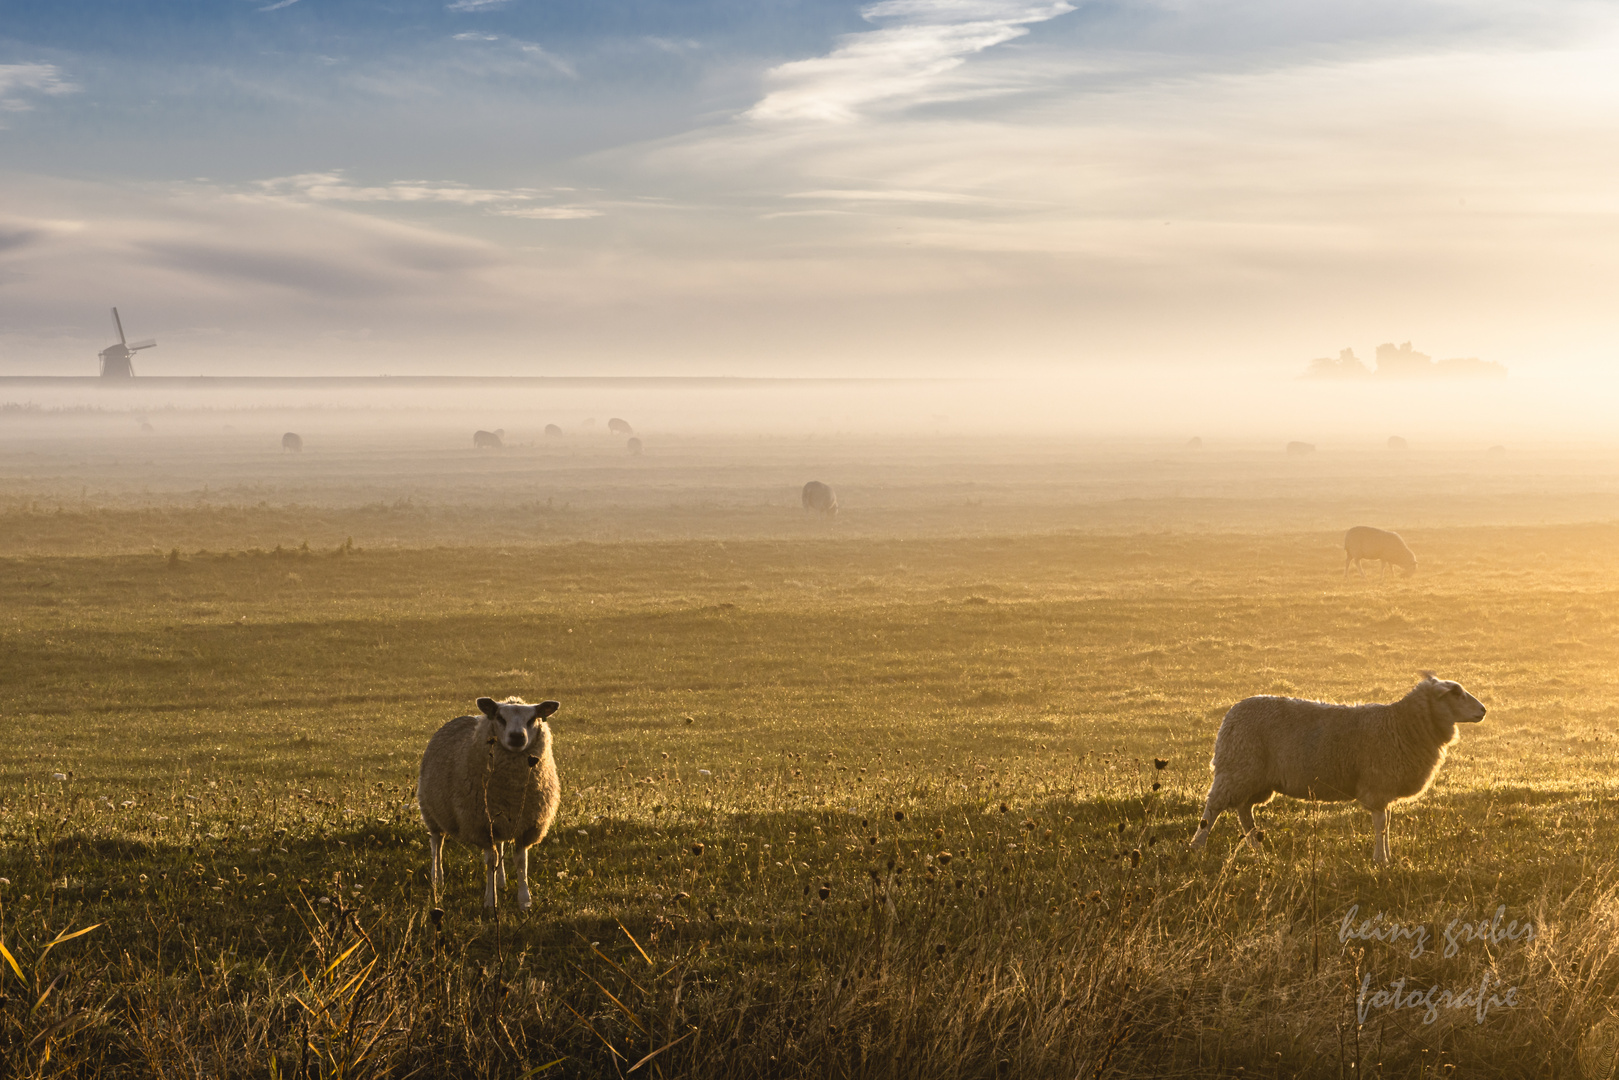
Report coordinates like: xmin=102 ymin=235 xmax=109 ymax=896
xmin=746 ymin=0 xmax=1073 ymax=120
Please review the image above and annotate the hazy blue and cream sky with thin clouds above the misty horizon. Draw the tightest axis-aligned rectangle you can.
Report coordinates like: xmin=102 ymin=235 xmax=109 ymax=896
xmin=0 ymin=0 xmax=1619 ymax=379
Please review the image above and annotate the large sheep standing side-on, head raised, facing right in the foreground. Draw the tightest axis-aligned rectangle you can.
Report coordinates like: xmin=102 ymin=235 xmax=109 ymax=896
xmin=1192 ymin=672 xmax=1485 ymax=863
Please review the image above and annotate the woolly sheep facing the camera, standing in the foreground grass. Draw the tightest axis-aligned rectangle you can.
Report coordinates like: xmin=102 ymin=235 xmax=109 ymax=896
xmin=416 ymin=698 xmax=562 ymax=908
